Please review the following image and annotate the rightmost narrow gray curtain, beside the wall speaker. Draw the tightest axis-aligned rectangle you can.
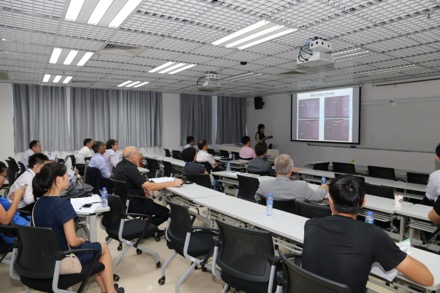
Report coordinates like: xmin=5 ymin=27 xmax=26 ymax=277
xmin=216 ymin=97 xmax=247 ymax=144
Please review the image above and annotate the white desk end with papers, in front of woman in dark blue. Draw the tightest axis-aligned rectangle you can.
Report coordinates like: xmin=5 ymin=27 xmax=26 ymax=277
xmin=70 ymin=194 xmax=110 ymax=242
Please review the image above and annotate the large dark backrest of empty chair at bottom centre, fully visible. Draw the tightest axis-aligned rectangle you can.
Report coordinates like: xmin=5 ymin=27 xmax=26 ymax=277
xmin=217 ymin=221 xmax=274 ymax=283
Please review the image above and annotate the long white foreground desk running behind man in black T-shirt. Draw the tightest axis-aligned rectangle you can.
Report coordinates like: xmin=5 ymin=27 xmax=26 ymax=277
xmin=167 ymin=184 xmax=440 ymax=291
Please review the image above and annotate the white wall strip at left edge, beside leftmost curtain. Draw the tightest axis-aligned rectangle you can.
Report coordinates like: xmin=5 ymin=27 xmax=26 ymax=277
xmin=0 ymin=83 xmax=14 ymax=163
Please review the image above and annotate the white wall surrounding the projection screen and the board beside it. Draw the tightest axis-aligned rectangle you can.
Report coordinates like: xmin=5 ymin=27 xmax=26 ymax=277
xmin=247 ymin=81 xmax=440 ymax=172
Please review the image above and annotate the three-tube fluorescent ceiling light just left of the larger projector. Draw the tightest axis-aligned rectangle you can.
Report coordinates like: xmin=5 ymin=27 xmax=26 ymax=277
xmin=212 ymin=20 xmax=297 ymax=50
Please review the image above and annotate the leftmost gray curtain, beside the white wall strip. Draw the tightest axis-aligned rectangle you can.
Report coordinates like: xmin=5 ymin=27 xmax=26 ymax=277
xmin=13 ymin=84 xmax=72 ymax=152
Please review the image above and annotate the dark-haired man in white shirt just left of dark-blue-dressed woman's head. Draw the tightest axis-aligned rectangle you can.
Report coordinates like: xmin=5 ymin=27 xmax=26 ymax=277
xmin=8 ymin=153 xmax=49 ymax=212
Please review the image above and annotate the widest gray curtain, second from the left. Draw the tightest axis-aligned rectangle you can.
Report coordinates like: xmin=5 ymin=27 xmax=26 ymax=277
xmin=70 ymin=88 xmax=162 ymax=149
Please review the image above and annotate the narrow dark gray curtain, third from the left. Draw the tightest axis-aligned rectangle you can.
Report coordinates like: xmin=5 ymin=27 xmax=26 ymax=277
xmin=180 ymin=94 xmax=212 ymax=144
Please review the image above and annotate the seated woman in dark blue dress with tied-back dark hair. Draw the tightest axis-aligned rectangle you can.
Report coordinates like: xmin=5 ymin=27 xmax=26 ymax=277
xmin=32 ymin=163 xmax=124 ymax=293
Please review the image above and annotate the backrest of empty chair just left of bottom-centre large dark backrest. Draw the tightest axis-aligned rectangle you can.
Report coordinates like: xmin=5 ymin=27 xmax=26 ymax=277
xmin=167 ymin=202 xmax=193 ymax=247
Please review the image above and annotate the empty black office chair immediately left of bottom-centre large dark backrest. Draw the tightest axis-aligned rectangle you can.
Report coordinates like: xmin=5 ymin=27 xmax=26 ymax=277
xmin=158 ymin=202 xmax=217 ymax=292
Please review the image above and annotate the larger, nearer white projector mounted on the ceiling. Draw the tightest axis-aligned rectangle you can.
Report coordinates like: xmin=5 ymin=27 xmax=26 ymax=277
xmin=296 ymin=37 xmax=335 ymax=68
